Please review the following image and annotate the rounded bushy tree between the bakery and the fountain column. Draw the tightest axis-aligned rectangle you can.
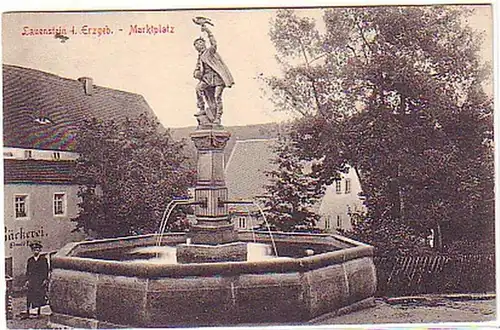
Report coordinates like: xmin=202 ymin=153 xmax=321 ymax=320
xmin=72 ymin=114 xmax=194 ymax=237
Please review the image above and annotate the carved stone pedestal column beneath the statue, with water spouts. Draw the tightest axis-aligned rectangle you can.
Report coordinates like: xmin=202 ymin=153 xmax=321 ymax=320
xmin=190 ymin=127 xmax=237 ymax=245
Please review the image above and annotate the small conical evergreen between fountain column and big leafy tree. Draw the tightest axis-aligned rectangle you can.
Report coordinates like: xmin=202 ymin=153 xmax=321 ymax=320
xmin=264 ymin=131 xmax=322 ymax=231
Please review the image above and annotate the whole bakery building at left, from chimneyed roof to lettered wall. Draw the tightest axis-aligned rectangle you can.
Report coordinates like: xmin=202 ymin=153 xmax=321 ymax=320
xmin=3 ymin=64 xmax=154 ymax=285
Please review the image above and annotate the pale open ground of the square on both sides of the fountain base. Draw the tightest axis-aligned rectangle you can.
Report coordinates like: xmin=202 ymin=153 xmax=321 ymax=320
xmin=3 ymin=297 xmax=496 ymax=329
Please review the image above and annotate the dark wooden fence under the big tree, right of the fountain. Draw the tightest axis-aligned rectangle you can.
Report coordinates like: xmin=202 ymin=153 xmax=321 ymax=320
xmin=374 ymin=254 xmax=495 ymax=297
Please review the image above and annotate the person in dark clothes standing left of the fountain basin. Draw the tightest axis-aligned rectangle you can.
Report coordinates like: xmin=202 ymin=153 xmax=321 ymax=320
xmin=26 ymin=241 xmax=49 ymax=317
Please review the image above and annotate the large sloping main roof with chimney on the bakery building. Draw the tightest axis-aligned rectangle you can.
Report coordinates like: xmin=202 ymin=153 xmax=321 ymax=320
xmin=3 ymin=64 xmax=154 ymax=151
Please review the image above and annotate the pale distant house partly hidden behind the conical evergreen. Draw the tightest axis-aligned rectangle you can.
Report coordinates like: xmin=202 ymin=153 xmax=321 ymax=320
xmin=225 ymin=139 xmax=364 ymax=232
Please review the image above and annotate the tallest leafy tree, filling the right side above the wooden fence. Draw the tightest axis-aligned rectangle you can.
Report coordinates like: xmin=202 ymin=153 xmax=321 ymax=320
xmin=264 ymin=6 xmax=494 ymax=253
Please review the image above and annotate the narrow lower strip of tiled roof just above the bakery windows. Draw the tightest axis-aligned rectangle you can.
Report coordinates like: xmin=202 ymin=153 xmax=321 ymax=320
xmin=4 ymin=159 xmax=76 ymax=184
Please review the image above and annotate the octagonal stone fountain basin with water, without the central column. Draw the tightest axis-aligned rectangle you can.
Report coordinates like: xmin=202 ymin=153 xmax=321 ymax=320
xmin=49 ymin=232 xmax=376 ymax=328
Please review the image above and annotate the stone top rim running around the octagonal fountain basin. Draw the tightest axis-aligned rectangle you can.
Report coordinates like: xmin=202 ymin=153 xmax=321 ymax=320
xmin=51 ymin=231 xmax=373 ymax=278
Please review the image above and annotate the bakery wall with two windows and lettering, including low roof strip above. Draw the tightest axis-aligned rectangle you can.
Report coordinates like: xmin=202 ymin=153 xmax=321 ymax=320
xmin=3 ymin=159 xmax=85 ymax=287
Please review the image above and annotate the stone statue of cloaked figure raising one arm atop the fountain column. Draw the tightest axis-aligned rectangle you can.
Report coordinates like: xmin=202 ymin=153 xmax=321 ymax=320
xmin=193 ymin=17 xmax=234 ymax=126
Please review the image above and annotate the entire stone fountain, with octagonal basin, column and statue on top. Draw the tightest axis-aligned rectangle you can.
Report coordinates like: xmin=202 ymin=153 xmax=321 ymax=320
xmin=49 ymin=20 xmax=376 ymax=328
